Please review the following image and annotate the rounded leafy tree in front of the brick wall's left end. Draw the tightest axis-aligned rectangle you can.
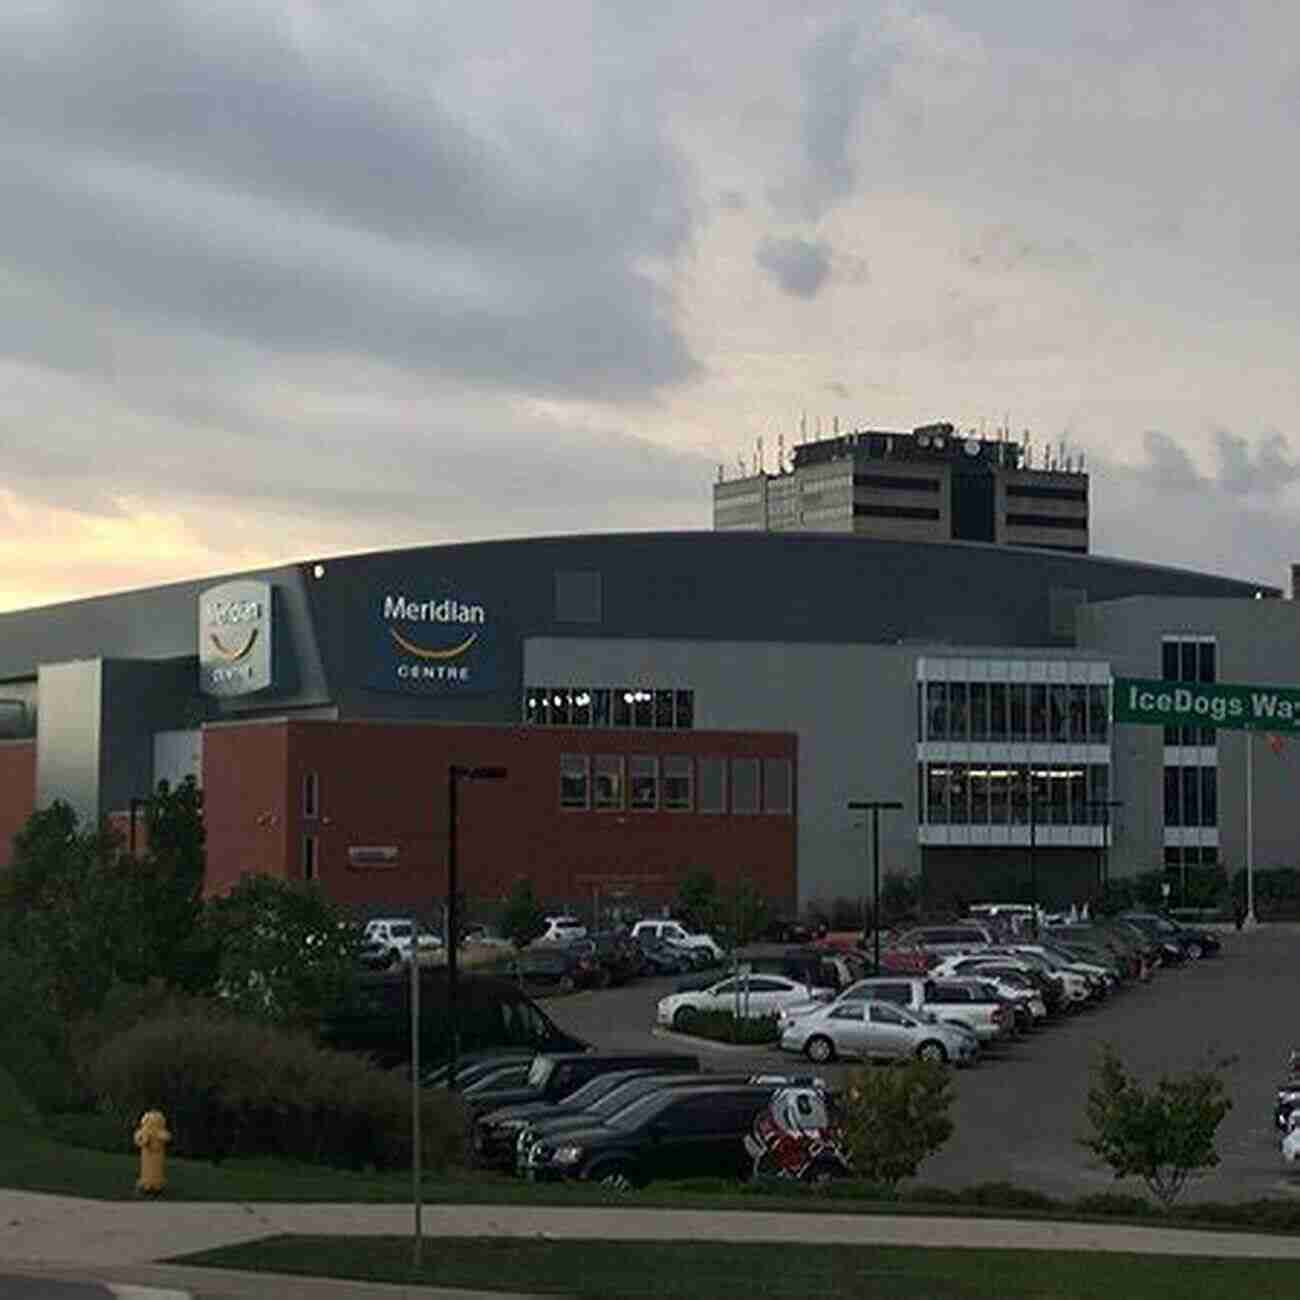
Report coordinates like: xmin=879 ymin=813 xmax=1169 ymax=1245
xmin=203 ymin=875 xmax=360 ymax=1026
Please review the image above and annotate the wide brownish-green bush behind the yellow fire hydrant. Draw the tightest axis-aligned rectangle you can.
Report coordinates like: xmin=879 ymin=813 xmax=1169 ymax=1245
xmin=87 ymin=1010 xmax=465 ymax=1169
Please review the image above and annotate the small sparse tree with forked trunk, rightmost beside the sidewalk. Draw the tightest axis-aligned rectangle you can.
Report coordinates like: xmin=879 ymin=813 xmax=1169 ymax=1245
xmin=1080 ymin=1048 xmax=1232 ymax=1210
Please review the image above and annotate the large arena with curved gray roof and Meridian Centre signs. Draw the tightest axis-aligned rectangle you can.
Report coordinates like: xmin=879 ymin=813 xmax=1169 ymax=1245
xmin=0 ymin=501 xmax=1300 ymax=909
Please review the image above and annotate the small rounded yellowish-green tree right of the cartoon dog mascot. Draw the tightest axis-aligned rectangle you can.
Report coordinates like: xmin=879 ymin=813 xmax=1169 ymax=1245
xmin=842 ymin=1060 xmax=953 ymax=1187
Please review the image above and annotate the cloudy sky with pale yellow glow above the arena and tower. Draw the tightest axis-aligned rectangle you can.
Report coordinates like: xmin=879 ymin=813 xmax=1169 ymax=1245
xmin=0 ymin=0 xmax=1300 ymax=608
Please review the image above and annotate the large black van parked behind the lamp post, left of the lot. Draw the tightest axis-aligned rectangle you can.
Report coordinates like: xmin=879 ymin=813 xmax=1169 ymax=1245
xmin=320 ymin=966 xmax=590 ymax=1069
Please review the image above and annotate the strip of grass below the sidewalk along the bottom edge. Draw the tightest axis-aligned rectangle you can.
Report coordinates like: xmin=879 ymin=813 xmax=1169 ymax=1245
xmin=169 ymin=1236 xmax=1300 ymax=1300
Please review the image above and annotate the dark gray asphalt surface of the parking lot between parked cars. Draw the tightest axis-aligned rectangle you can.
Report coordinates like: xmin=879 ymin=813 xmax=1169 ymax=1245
xmin=545 ymin=926 xmax=1300 ymax=1200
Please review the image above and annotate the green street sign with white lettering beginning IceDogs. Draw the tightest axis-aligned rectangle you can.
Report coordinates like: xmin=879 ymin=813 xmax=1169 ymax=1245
xmin=1112 ymin=677 xmax=1300 ymax=732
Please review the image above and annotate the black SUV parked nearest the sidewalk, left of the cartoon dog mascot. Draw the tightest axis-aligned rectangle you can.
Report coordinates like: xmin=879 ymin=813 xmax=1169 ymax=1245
xmin=527 ymin=1083 xmax=780 ymax=1188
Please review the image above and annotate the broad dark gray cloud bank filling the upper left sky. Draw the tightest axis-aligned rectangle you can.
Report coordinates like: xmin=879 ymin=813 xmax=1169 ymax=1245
xmin=0 ymin=0 xmax=696 ymax=398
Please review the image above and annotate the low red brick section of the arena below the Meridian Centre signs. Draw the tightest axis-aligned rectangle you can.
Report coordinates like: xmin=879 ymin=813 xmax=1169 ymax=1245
xmin=203 ymin=720 xmax=798 ymax=918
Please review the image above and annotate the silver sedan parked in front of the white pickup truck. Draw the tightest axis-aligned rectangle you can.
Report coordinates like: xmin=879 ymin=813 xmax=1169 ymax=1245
xmin=781 ymin=997 xmax=979 ymax=1065
